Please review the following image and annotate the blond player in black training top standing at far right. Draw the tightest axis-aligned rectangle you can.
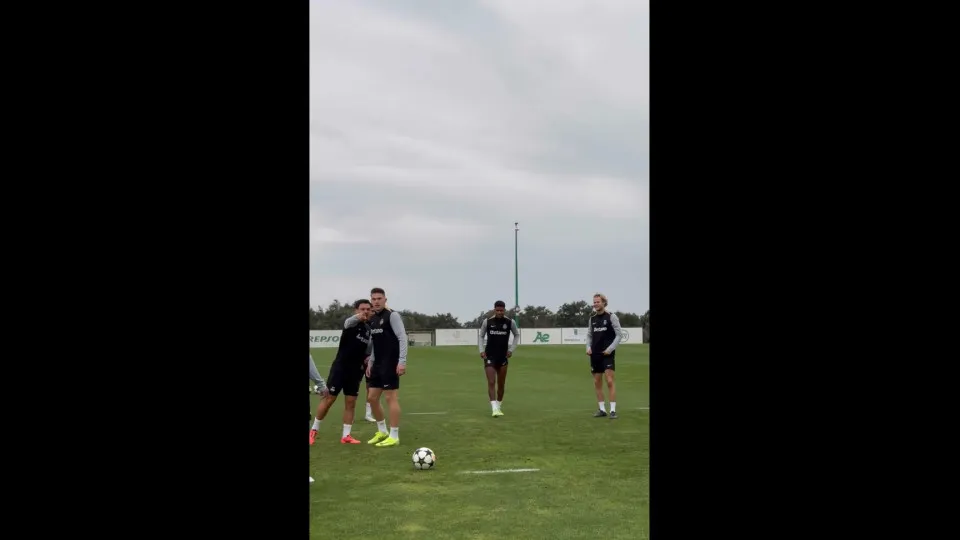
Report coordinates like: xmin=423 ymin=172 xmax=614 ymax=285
xmin=587 ymin=293 xmax=620 ymax=418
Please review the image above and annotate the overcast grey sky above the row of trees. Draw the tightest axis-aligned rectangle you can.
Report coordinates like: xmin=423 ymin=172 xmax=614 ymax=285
xmin=310 ymin=0 xmax=650 ymax=322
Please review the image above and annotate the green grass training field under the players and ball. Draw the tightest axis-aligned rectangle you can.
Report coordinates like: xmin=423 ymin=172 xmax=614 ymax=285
xmin=312 ymin=345 xmax=650 ymax=540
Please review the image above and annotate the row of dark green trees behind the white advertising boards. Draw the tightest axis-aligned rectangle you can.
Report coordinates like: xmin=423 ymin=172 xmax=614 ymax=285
xmin=310 ymin=300 xmax=650 ymax=335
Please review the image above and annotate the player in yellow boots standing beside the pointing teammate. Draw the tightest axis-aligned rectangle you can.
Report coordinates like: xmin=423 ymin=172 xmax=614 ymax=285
xmin=367 ymin=287 xmax=407 ymax=448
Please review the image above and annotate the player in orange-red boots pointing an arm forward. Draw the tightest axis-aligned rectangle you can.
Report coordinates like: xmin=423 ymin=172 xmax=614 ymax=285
xmin=310 ymin=300 xmax=373 ymax=444
